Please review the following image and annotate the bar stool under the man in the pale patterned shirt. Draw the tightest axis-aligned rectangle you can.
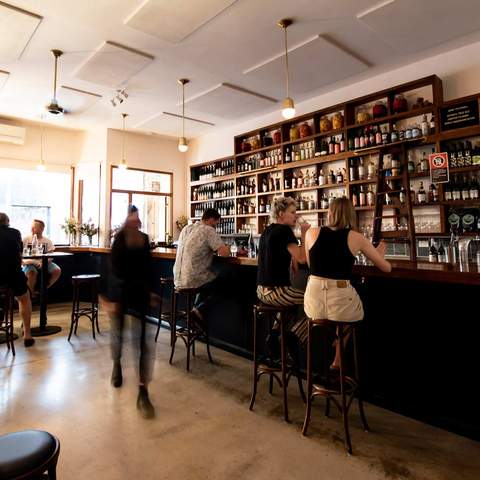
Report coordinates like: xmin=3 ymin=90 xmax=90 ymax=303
xmin=169 ymin=288 xmax=213 ymax=371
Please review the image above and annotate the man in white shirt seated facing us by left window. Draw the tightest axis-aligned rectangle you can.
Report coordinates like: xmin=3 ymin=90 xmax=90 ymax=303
xmin=22 ymin=219 xmax=62 ymax=294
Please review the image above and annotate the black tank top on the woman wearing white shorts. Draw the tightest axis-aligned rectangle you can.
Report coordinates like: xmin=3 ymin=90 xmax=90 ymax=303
xmin=309 ymin=227 xmax=355 ymax=280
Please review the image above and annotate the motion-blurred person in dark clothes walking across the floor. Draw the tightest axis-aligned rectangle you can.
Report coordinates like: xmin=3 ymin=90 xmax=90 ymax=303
xmin=104 ymin=205 xmax=155 ymax=418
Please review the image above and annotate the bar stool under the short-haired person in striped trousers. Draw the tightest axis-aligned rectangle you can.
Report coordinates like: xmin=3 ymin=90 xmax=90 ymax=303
xmin=249 ymin=303 xmax=306 ymax=422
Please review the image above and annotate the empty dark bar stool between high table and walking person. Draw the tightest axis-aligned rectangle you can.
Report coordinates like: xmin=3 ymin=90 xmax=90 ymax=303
xmin=68 ymin=274 xmax=100 ymax=341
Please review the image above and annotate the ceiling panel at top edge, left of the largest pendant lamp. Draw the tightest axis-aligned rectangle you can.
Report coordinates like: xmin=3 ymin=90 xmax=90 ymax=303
xmin=125 ymin=0 xmax=237 ymax=43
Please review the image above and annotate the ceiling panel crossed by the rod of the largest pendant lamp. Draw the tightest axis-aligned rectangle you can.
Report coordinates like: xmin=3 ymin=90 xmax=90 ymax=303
xmin=244 ymin=35 xmax=368 ymax=96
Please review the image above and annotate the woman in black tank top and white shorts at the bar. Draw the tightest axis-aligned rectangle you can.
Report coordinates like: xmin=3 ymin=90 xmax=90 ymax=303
xmin=305 ymin=197 xmax=392 ymax=369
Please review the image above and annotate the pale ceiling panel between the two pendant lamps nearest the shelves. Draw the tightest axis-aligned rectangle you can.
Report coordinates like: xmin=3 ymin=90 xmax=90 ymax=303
xmin=185 ymin=83 xmax=278 ymax=118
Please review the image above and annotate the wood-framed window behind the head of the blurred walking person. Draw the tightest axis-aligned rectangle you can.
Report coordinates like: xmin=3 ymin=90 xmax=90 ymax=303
xmin=110 ymin=167 xmax=173 ymax=242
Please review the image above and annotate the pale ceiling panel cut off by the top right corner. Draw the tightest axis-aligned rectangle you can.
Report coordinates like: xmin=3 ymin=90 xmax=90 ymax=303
xmin=357 ymin=0 xmax=480 ymax=53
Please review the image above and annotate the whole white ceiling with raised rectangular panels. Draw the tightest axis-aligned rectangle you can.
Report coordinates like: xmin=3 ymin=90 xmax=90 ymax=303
xmin=0 ymin=0 xmax=480 ymax=137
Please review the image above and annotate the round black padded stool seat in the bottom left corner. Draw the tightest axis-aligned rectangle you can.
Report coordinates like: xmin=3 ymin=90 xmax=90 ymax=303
xmin=0 ymin=430 xmax=60 ymax=480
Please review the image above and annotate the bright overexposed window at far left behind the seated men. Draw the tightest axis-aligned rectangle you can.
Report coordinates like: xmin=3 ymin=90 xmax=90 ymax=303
xmin=0 ymin=168 xmax=71 ymax=243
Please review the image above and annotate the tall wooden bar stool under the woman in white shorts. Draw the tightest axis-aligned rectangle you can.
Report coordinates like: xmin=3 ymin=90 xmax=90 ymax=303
xmin=302 ymin=319 xmax=370 ymax=454
